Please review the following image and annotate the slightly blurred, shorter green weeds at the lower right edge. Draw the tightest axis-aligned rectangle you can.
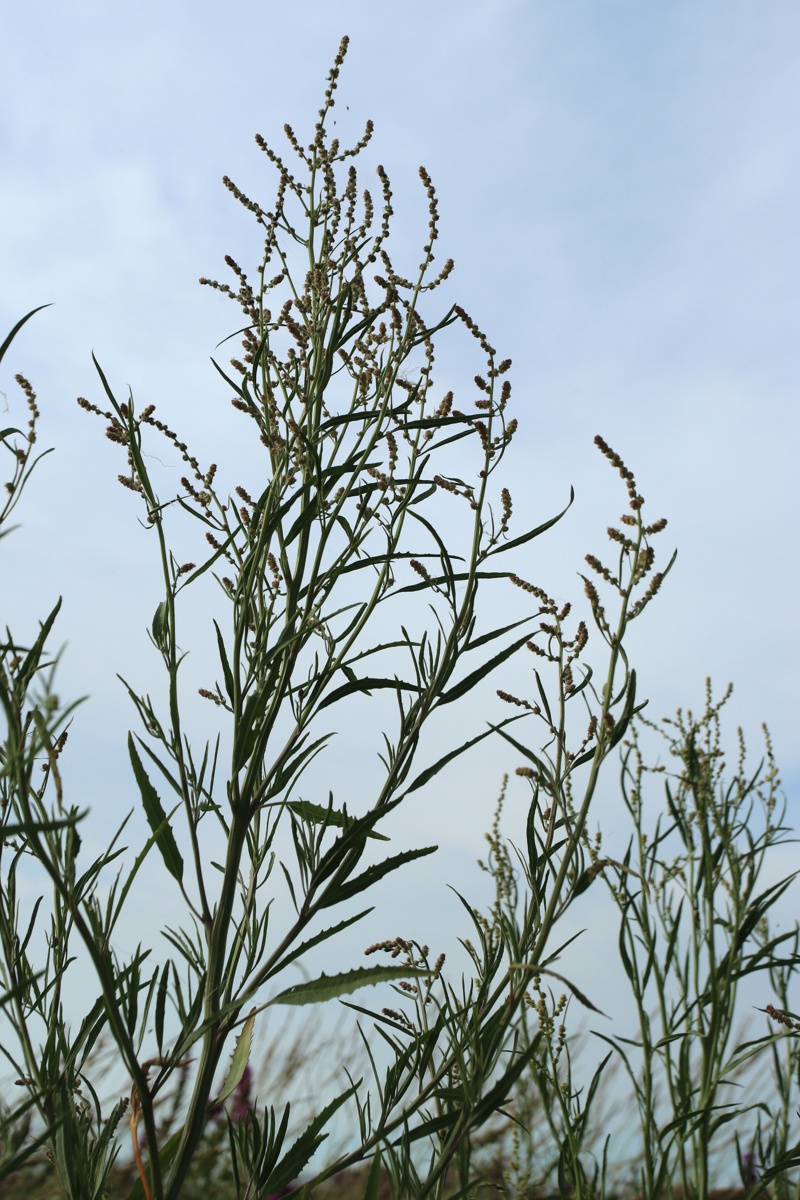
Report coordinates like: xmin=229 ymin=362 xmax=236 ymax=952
xmin=488 ymin=684 xmax=800 ymax=1198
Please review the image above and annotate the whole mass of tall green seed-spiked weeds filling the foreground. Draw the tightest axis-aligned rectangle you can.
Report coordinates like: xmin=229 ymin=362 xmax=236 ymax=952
xmin=0 ymin=40 xmax=800 ymax=1200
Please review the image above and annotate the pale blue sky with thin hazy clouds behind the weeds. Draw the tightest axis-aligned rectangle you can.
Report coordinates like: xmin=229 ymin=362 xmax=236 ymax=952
xmin=0 ymin=0 xmax=800 ymax=1161
